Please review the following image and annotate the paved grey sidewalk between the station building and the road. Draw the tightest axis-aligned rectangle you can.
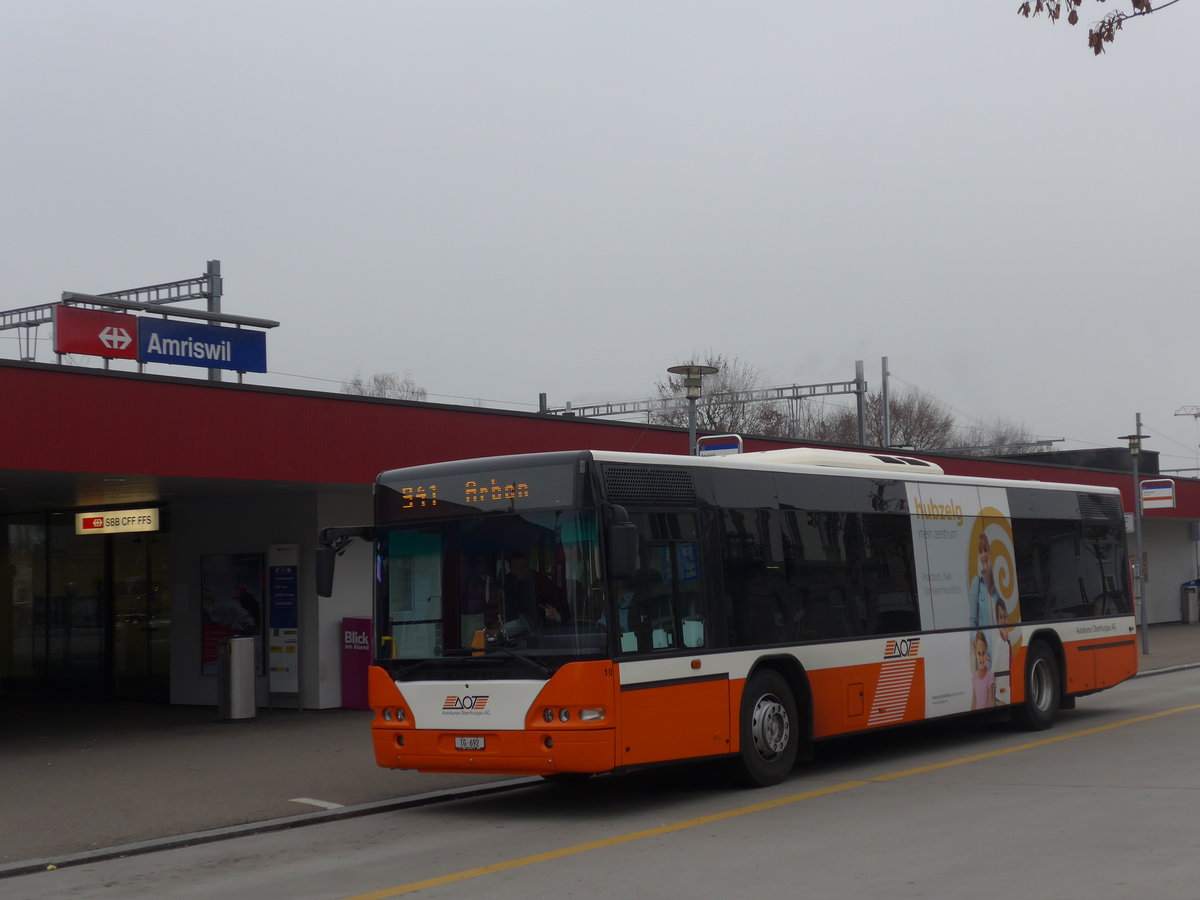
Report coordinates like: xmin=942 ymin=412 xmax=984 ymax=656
xmin=0 ymin=624 xmax=1200 ymax=878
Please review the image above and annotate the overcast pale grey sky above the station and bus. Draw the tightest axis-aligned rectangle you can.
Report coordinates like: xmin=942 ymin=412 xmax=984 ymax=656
xmin=9 ymin=0 xmax=1200 ymax=468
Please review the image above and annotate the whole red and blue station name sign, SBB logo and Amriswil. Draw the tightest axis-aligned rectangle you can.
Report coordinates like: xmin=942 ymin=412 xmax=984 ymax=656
xmin=54 ymin=304 xmax=266 ymax=372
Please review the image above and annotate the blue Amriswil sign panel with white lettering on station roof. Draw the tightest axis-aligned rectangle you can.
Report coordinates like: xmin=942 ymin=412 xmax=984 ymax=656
xmin=138 ymin=317 xmax=266 ymax=372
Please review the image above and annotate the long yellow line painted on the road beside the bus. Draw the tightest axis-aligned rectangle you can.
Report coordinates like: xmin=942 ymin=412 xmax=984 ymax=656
xmin=343 ymin=703 xmax=1200 ymax=900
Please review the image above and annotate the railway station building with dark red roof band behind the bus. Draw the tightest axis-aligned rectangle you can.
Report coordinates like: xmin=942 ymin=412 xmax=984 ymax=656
xmin=7 ymin=361 xmax=1200 ymax=708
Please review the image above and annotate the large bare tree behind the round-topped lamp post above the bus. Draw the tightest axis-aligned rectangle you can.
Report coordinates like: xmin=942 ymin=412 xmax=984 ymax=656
xmin=650 ymin=350 xmax=788 ymax=436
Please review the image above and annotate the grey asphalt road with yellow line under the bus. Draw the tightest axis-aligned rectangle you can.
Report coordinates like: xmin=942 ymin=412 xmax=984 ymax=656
xmin=9 ymin=670 xmax=1200 ymax=900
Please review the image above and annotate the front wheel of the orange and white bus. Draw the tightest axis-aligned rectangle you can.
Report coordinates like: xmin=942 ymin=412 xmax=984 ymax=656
xmin=736 ymin=668 xmax=800 ymax=787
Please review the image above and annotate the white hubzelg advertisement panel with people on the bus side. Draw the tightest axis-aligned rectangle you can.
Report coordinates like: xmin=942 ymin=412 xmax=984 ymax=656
xmin=908 ymin=484 xmax=1020 ymax=716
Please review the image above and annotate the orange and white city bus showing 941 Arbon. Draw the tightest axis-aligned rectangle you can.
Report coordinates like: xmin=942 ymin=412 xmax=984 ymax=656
xmin=318 ymin=449 xmax=1138 ymax=785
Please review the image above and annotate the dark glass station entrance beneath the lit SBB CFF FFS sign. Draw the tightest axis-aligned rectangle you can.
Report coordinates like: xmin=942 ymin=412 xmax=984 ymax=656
xmin=0 ymin=514 xmax=170 ymax=701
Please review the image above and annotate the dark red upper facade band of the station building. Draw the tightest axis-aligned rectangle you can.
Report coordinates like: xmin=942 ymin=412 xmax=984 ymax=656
xmin=9 ymin=362 xmax=1200 ymax=518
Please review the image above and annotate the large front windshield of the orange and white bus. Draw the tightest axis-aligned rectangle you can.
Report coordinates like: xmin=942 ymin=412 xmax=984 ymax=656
xmin=376 ymin=510 xmax=608 ymax=666
